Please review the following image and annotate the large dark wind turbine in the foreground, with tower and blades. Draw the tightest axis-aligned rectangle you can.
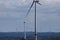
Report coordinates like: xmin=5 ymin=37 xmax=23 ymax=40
xmin=26 ymin=0 xmax=41 ymax=40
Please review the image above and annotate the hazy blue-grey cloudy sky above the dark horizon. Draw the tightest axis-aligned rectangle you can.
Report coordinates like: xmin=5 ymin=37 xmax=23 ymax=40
xmin=0 ymin=0 xmax=60 ymax=32
